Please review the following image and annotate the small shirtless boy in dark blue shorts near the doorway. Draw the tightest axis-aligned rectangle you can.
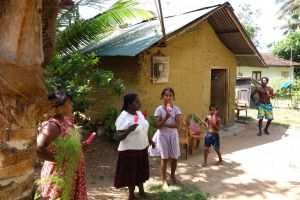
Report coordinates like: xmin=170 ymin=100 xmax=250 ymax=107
xmin=202 ymin=104 xmax=223 ymax=167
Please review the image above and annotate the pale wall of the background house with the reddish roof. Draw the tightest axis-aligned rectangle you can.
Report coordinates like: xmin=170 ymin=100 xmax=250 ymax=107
xmin=237 ymin=66 xmax=294 ymax=79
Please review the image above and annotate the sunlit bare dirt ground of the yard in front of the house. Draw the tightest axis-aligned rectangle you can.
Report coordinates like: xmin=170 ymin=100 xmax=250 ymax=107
xmin=86 ymin=121 xmax=300 ymax=200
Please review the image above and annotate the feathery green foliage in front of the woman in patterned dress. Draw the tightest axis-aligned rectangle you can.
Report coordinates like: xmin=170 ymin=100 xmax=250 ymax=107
xmin=36 ymin=128 xmax=81 ymax=200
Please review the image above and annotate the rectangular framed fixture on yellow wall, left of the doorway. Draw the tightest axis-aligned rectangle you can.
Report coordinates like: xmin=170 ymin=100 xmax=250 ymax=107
xmin=152 ymin=56 xmax=169 ymax=83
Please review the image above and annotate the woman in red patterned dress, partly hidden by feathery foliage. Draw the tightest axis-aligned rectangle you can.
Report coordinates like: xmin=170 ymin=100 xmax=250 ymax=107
xmin=36 ymin=91 xmax=87 ymax=200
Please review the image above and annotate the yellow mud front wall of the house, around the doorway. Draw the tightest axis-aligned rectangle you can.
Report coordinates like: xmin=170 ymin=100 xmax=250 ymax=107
xmin=138 ymin=21 xmax=236 ymax=123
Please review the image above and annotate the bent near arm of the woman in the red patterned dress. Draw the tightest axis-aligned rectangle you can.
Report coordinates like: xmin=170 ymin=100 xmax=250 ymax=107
xmin=36 ymin=122 xmax=60 ymax=162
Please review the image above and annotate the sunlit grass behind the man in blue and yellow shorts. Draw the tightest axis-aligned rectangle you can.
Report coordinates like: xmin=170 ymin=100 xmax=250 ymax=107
xmin=240 ymin=108 xmax=300 ymax=129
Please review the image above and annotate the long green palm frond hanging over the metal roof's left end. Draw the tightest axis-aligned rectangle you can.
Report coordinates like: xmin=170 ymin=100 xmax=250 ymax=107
xmin=56 ymin=0 xmax=154 ymax=55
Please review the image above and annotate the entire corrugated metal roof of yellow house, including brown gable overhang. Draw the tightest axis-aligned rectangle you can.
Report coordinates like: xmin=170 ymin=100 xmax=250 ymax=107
xmin=84 ymin=3 xmax=265 ymax=66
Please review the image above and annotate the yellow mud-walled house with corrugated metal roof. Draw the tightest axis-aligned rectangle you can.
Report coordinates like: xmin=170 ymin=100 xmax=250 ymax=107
xmin=84 ymin=3 xmax=265 ymax=124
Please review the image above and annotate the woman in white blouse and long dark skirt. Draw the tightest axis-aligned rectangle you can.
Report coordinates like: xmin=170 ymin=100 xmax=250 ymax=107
xmin=114 ymin=93 xmax=155 ymax=200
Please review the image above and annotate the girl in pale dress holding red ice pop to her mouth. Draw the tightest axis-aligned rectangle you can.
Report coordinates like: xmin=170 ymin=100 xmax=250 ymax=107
xmin=150 ymin=87 xmax=181 ymax=190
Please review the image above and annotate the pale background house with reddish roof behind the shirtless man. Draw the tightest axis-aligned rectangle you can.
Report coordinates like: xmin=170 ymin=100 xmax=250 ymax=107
xmin=237 ymin=53 xmax=300 ymax=80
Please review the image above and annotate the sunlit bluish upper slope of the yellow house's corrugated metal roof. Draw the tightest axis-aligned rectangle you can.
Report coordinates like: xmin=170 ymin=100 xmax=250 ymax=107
xmin=83 ymin=7 xmax=214 ymax=56
